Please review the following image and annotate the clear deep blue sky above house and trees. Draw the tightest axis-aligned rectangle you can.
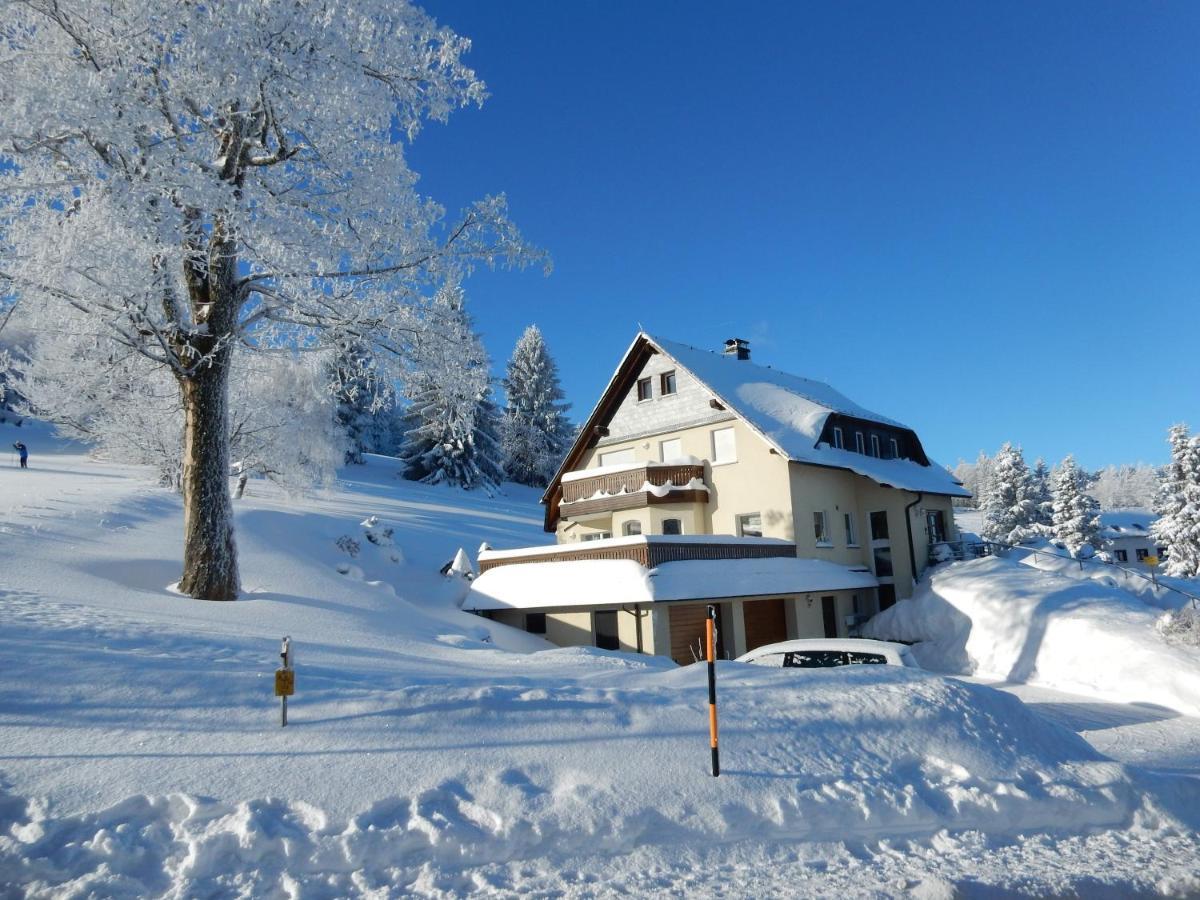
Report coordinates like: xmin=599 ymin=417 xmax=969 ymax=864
xmin=412 ymin=0 xmax=1200 ymax=467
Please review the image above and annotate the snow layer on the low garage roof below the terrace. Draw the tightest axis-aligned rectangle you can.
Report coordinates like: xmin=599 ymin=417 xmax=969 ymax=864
xmin=462 ymin=556 xmax=878 ymax=611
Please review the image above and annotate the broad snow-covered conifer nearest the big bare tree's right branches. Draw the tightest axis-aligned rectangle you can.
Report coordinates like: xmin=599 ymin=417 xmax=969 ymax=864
xmin=400 ymin=281 xmax=504 ymax=492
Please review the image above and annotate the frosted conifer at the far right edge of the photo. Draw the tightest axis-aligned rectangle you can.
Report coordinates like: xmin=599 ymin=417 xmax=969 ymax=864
xmin=1152 ymin=425 xmax=1200 ymax=578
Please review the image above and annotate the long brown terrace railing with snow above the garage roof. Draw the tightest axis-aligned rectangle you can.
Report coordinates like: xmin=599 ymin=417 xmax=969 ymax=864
xmin=479 ymin=534 xmax=796 ymax=574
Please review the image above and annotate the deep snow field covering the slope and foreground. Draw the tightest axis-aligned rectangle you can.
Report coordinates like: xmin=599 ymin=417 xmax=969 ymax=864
xmin=0 ymin=425 xmax=1200 ymax=898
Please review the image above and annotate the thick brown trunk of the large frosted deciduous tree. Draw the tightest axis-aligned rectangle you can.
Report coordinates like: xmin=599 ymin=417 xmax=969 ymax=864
xmin=179 ymin=346 xmax=239 ymax=600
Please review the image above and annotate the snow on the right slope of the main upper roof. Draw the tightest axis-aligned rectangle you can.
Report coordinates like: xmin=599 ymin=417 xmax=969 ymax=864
xmin=647 ymin=335 xmax=971 ymax=497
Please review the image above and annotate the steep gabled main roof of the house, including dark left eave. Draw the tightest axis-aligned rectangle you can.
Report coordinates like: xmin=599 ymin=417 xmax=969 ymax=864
xmin=542 ymin=332 xmax=971 ymax=523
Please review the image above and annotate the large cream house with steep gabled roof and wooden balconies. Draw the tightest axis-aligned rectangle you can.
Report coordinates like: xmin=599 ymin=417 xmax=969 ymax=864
xmin=464 ymin=334 xmax=968 ymax=662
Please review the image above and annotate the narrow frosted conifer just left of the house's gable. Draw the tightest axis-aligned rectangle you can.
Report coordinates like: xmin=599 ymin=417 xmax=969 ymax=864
xmin=500 ymin=325 xmax=575 ymax=486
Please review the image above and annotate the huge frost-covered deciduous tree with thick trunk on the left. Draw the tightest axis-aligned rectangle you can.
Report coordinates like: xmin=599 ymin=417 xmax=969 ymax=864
xmin=0 ymin=0 xmax=535 ymax=600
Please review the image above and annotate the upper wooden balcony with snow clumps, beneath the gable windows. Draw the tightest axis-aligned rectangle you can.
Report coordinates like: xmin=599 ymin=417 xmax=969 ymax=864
xmin=559 ymin=462 xmax=708 ymax=516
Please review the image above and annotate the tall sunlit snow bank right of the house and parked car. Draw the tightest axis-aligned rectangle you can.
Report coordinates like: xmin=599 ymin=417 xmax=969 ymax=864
xmin=863 ymin=557 xmax=1200 ymax=715
